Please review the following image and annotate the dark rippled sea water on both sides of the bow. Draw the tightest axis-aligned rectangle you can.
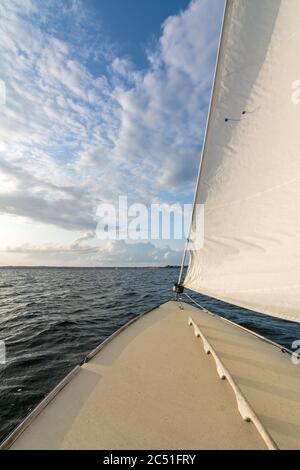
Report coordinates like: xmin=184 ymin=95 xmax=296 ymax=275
xmin=0 ymin=268 xmax=300 ymax=441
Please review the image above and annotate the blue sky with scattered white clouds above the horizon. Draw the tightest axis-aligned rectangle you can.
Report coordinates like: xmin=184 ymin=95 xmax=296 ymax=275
xmin=0 ymin=0 xmax=223 ymax=266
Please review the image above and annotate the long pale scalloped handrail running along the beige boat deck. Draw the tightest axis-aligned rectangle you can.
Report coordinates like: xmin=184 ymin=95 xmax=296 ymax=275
xmin=188 ymin=317 xmax=279 ymax=450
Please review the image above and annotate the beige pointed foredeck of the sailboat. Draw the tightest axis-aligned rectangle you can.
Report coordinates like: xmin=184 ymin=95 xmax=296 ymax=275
xmin=3 ymin=302 xmax=300 ymax=450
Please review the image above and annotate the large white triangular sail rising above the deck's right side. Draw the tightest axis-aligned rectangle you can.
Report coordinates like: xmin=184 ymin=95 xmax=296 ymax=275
xmin=184 ymin=0 xmax=300 ymax=322
